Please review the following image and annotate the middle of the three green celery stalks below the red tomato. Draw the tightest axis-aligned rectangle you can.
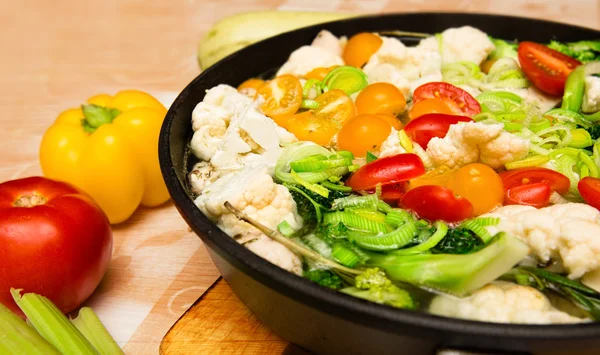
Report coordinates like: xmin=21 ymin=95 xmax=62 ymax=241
xmin=10 ymin=289 xmax=98 ymax=355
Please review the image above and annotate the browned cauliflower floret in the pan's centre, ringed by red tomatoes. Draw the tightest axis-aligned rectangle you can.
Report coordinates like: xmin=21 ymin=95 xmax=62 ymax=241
xmin=427 ymin=122 xmax=529 ymax=169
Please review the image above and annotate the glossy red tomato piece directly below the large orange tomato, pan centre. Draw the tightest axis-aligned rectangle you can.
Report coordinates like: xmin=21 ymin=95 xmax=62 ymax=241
xmin=402 ymin=185 xmax=473 ymax=222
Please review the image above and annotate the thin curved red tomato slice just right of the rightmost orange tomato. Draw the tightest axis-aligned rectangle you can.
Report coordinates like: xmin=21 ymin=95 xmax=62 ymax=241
xmin=500 ymin=167 xmax=571 ymax=194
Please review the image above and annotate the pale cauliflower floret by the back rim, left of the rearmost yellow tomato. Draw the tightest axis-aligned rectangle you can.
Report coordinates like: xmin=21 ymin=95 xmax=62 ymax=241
xmin=277 ymin=46 xmax=344 ymax=76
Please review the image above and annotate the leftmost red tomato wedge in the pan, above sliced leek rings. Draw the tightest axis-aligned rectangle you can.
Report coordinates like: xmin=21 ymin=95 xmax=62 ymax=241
xmin=346 ymin=153 xmax=425 ymax=190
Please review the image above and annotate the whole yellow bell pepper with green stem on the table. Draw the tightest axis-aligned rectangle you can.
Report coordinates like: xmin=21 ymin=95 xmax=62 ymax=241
xmin=40 ymin=90 xmax=169 ymax=224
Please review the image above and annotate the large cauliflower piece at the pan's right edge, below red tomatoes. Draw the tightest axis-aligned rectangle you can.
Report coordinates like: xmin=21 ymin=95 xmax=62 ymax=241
xmin=484 ymin=203 xmax=600 ymax=279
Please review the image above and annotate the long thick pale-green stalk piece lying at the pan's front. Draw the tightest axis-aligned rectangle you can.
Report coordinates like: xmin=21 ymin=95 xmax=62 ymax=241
xmin=367 ymin=233 xmax=529 ymax=296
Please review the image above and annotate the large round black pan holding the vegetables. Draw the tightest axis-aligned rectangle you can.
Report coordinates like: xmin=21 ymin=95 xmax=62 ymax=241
xmin=159 ymin=13 xmax=600 ymax=354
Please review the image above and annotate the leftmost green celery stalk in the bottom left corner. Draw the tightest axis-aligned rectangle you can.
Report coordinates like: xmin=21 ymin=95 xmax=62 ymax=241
xmin=0 ymin=303 xmax=60 ymax=355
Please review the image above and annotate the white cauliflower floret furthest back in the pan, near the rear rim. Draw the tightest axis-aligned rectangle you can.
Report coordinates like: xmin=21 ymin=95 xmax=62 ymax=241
xmin=417 ymin=26 xmax=495 ymax=65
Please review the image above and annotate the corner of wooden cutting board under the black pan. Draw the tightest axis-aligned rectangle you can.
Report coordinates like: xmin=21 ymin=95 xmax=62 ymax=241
xmin=160 ymin=278 xmax=308 ymax=355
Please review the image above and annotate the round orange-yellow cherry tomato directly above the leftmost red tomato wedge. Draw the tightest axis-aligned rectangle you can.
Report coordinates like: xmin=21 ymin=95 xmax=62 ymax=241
xmin=337 ymin=114 xmax=392 ymax=158
